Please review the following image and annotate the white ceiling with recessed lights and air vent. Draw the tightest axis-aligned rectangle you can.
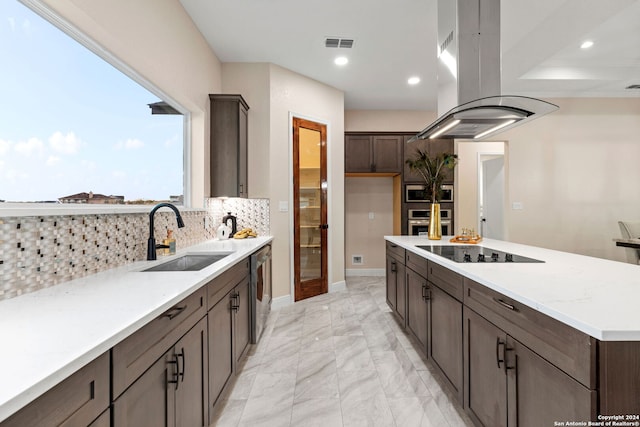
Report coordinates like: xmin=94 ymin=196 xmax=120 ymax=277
xmin=180 ymin=0 xmax=640 ymax=111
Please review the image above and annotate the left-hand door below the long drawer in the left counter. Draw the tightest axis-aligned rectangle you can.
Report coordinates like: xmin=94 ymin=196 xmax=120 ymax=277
xmin=113 ymin=350 xmax=172 ymax=427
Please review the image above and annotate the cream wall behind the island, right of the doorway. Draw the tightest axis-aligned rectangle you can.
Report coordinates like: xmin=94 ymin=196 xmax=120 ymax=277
xmin=500 ymin=98 xmax=640 ymax=261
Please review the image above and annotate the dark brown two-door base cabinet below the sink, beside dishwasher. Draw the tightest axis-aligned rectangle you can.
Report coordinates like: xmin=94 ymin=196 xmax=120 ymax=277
xmin=208 ymin=261 xmax=251 ymax=423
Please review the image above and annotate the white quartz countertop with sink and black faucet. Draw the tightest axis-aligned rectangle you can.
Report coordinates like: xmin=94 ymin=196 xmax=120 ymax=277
xmin=0 ymin=237 xmax=272 ymax=422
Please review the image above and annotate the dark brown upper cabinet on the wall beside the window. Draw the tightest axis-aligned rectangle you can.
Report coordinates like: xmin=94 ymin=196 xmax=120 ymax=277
xmin=209 ymin=95 xmax=249 ymax=198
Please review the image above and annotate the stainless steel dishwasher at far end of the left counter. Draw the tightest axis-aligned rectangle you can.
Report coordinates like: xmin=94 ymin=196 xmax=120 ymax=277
xmin=249 ymin=245 xmax=272 ymax=344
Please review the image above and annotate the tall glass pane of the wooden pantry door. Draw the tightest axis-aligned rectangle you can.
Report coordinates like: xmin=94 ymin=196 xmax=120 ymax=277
xmin=298 ymin=128 xmax=322 ymax=280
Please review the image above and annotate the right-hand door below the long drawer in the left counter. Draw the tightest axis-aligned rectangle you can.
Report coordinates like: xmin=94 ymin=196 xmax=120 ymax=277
xmin=171 ymin=319 xmax=209 ymax=427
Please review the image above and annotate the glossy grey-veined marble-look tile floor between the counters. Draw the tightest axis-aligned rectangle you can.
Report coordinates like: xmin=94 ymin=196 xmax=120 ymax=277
xmin=212 ymin=277 xmax=472 ymax=427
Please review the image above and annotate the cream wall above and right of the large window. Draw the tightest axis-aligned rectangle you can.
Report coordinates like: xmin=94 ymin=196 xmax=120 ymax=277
xmin=42 ymin=0 xmax=222 ymax=207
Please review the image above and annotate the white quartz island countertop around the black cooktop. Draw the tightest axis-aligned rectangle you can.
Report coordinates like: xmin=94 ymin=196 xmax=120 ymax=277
xmin=385 ymin=236 xmax=640 ymax=341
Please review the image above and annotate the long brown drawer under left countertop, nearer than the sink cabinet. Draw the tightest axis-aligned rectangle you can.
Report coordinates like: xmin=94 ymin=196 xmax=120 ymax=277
xmin=112 ymin=287 xmax=207 ymax=398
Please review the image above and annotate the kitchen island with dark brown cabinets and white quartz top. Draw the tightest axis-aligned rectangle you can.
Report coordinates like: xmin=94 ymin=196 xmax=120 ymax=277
xmin=385 ymin=236 xmax=640 ymax=426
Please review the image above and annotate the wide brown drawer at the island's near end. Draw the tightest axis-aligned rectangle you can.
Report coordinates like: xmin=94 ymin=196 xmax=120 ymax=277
xmin=464 ymin=278 xmax=596 ymax=389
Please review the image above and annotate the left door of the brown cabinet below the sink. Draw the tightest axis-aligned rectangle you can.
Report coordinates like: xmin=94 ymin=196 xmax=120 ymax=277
xmin=208 ymin=291 xmax=233 ymax=414
